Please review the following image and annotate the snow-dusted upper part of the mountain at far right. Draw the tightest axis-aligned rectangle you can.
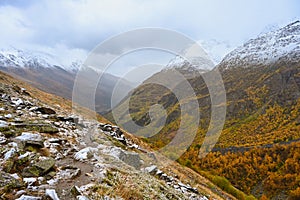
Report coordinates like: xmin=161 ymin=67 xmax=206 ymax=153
xmin=221 ymin=21 xmax=300 ymax=69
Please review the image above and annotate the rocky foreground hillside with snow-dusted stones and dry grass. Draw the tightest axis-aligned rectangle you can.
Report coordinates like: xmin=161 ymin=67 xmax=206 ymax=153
xmin=0 ymin=84 xmax=229 ymax=200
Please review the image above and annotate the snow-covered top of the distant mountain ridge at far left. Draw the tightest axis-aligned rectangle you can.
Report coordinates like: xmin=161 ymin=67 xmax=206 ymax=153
xmin=0 ymin=47 xmax=82 ymax=72
